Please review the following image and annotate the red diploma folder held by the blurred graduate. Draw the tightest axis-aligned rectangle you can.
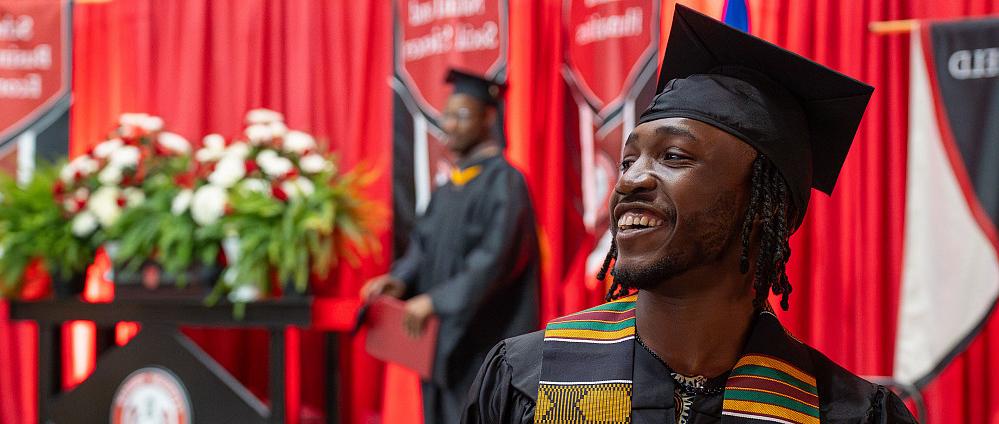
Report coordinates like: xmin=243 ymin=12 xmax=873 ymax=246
xmin=365 ymin=296 xmax=440 ymax=380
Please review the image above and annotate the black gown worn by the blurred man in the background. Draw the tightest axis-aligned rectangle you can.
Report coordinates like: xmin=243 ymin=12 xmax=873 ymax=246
xmin=391 ymin=155 xmax=540 ymax=390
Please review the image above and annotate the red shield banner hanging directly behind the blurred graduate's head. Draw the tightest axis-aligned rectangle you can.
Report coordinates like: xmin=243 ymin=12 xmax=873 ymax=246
xmin=392 ymin=0 xmax=508 ymax=256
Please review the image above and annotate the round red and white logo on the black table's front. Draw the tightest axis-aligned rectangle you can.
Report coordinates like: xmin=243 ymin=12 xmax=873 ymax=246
xmin=111 ymin=367 xmax=192 ymax=424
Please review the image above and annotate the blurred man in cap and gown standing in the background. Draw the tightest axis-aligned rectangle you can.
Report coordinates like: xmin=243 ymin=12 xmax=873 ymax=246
xmin=361 ymin=70 xmax=539 ymax=424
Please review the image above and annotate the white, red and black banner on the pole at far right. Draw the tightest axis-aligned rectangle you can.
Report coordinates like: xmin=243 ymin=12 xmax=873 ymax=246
xmin=894 ymin=18 xmax=999 ymax=387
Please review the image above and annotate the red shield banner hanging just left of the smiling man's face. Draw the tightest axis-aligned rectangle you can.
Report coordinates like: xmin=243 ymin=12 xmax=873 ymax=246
xmin=563 ymin=0 xmax=660 ymax=290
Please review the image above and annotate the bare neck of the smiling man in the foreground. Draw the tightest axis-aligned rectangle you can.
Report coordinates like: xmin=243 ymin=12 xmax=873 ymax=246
xmin=636 ymin=266 xmax=754 ymax=378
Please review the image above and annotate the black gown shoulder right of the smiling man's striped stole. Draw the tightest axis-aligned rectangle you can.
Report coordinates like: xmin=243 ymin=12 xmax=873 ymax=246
xmin=808 ymin=347 xmax=917 ymax=424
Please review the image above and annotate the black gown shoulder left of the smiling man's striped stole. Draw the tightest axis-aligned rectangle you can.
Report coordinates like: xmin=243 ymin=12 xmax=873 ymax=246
xmin=461 ymin=331 xmax=544 ymax=424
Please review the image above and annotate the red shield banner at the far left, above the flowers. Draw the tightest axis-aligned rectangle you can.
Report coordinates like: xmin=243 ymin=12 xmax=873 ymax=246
xmin=0 ymin=0 xmax=72 ymax=177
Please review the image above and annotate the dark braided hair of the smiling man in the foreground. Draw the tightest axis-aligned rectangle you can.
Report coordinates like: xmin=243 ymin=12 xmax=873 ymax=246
xmin=597 ymin=154 xmax=795 ymax=311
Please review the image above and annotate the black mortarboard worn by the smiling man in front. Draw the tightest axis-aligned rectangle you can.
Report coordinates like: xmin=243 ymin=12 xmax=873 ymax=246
xmin=638 ymin=5 xmax=874 ymax=228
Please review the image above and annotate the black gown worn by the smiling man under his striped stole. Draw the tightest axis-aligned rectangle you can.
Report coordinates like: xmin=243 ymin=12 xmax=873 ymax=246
xmin=462 ymin=316 xmax=916 ymax=424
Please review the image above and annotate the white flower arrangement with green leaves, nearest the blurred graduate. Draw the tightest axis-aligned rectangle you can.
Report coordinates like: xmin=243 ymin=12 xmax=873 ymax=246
xmin=183 ymin=109 xmax=378 ymax=302
